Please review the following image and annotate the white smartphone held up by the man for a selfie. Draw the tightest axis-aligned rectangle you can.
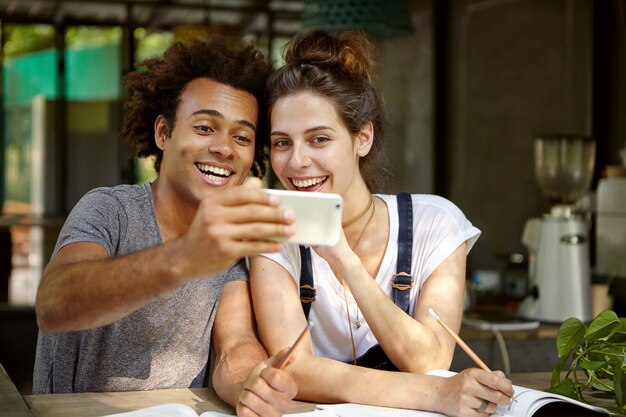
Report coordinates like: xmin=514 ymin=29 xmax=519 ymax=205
xmin=262 ymin=188 xmax=343 ymax=246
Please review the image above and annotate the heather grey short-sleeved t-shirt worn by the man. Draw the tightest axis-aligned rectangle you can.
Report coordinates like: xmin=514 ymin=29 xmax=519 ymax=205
xmin=33 ymin=184 xmax=248 ymax=394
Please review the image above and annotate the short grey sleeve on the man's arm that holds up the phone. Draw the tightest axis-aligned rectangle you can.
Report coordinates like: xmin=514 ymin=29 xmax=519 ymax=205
xmin=54 ymin=188 xmax=128 ymax=255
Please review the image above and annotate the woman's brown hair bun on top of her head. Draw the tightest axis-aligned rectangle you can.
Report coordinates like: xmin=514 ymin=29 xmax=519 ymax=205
xmin=285 ymin=30 xmax=374 ymax=80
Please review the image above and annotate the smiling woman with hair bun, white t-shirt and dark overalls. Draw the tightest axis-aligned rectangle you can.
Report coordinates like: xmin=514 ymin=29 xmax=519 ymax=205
xmin=250 ymin=31 xmax=512 ymax=416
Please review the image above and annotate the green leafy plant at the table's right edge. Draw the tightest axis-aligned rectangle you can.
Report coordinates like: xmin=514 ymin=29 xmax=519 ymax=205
xmin=549 ymin=310 xmax=626 ymax=413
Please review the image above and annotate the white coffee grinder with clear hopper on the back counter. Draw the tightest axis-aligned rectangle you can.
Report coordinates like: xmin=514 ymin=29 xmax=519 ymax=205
xmin=518 ymin=136 xmax=595 ymax=323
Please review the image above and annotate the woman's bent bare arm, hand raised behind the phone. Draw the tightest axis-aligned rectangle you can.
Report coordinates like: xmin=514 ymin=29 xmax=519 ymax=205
xmin=316 ymin=231 xmax=467 ymax=373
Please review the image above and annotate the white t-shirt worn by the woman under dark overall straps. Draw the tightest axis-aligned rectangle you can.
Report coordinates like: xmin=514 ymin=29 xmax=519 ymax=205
xmin=263 ymin=194 xmax=480 ymax=362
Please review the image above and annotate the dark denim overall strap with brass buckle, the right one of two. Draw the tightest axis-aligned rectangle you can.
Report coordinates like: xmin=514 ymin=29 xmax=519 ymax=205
xmin=391 ymin=193 xmax=413 ymax=314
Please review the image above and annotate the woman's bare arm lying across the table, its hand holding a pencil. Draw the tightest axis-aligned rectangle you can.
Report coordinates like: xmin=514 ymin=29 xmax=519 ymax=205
xmin=250 ymin=257 xmax=512 ymax=416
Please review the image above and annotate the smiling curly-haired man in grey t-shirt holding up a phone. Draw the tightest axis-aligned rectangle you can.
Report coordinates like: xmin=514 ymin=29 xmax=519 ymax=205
xmin=33 ymin=39 xmax=296 ymax=415
